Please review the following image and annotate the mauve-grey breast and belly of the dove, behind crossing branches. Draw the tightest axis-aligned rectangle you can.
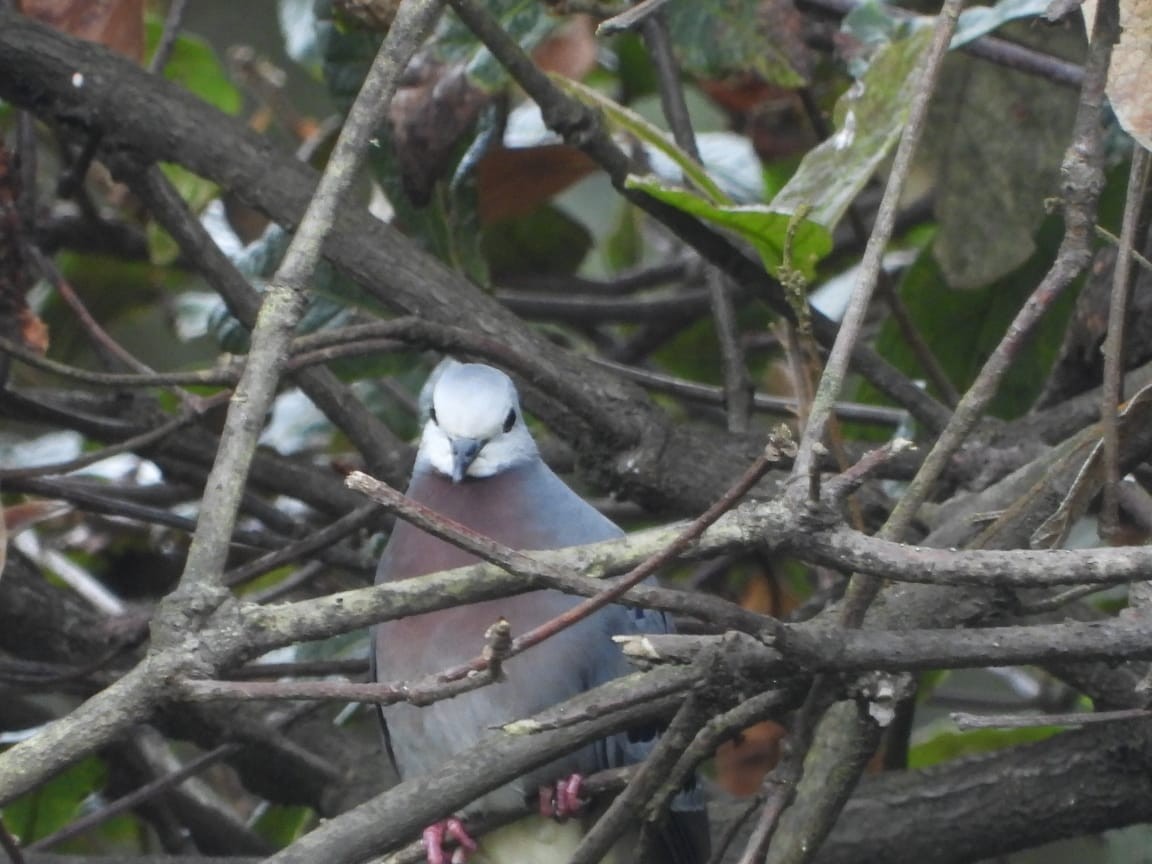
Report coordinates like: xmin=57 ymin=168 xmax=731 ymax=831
xmin=374 ymin=462 xmax=706 ymax=864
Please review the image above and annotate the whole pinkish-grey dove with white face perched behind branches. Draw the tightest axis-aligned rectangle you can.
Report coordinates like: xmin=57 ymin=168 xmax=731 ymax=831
xmin=372 ymin=359 xmax=707 ymax=864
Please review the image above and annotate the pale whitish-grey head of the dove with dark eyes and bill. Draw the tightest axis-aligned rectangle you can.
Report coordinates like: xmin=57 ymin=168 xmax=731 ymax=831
xmin=416 ymin=363 xmax=537 ymax=483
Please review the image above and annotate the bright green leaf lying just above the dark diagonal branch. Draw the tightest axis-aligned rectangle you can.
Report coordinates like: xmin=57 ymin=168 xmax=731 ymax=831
xmin=624 ymin=176 xmax=832 ymax=280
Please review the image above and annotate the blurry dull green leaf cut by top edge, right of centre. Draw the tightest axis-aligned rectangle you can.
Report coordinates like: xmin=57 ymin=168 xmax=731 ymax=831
xmin=664 ymin=0 xmax=806 ymax=88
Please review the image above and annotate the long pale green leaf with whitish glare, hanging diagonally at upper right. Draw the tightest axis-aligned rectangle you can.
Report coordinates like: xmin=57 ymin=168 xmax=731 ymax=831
xmin=771 ymin=30 xmax=932 ymax=230
